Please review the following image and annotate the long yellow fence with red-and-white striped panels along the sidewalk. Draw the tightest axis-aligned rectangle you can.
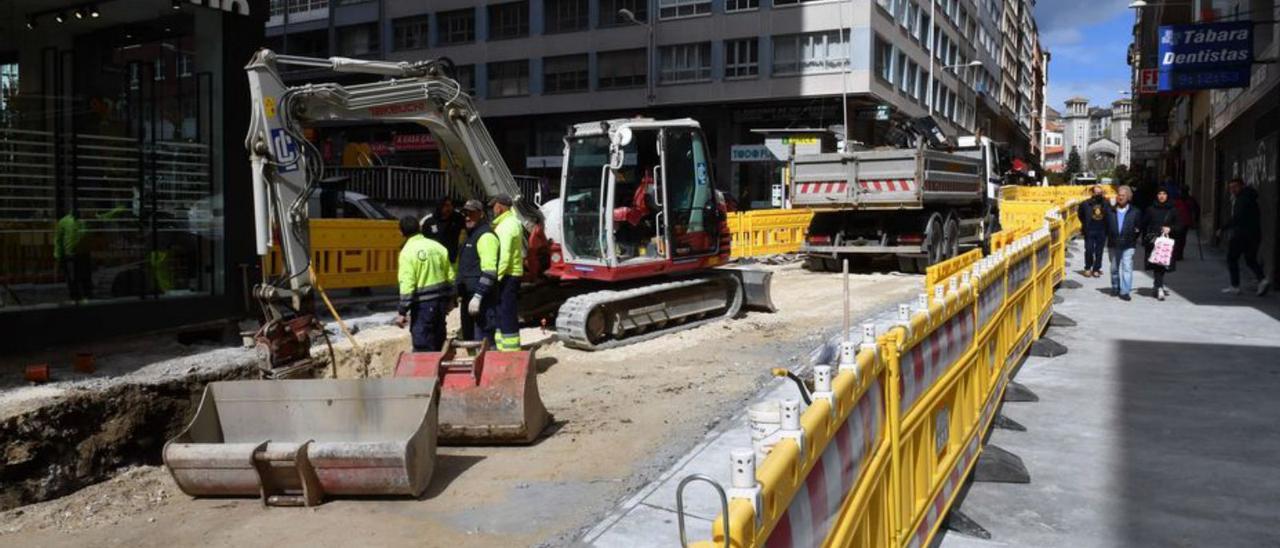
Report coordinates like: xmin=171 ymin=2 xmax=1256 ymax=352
xmin=698 ymin=211 xmax=1066 ymax=548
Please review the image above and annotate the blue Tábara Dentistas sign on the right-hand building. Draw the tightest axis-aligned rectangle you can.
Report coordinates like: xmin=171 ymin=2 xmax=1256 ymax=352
xmin=1157 ymin=20 xmax=1253 ymax=92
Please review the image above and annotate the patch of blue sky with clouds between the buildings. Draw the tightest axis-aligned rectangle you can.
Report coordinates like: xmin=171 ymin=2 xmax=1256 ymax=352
xmin=1036 ymin=0 xmax=1134 ymax=113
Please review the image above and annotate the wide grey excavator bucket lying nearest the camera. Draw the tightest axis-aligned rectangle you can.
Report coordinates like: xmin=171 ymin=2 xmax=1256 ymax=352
xmin=164 ymin=376 xmax=439 ymax=506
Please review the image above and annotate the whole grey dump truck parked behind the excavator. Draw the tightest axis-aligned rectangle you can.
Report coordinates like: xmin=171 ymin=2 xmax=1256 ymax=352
xmin=788 ymin=121 xmax=1004 ymax=273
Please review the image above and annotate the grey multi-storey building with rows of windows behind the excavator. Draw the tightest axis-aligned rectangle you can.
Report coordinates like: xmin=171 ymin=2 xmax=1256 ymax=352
xmin=266 ymin=0 xmax=1029 ymax=202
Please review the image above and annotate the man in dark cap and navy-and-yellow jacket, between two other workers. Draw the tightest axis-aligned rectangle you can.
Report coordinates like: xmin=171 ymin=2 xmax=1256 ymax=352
xmin=458 ymin=200 xmax=499 ymax=346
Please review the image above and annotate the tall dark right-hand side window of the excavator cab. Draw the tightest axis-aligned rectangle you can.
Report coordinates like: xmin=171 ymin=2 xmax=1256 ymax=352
xmin=662 ymin=127 xmax=719 ymax=257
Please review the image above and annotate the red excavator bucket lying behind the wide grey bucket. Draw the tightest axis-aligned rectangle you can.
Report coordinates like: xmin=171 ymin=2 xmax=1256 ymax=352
xmin=396 ymin=341 xmax=552 ymax=446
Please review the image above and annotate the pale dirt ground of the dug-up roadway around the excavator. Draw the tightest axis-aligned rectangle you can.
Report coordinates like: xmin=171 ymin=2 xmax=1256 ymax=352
xmin=0 ymin=264 xmax=920 ymax=547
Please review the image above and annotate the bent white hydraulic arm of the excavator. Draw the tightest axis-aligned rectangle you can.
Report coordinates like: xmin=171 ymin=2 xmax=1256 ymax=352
xmin=244 ymin=49 xmax=543 ymax=369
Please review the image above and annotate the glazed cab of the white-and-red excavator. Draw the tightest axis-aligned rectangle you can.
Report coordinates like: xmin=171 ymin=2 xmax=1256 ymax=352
xmin=561 ymin=119 xmax=723 ymax=278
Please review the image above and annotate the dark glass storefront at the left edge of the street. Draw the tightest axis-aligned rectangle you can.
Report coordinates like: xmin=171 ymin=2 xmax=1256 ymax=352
xmin=0 ymin=0 xmax=266 ymax=351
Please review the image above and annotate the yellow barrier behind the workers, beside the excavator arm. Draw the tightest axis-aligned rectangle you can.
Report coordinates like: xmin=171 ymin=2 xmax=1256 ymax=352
xmin=268 ymin=219 xmax=404 ymax=289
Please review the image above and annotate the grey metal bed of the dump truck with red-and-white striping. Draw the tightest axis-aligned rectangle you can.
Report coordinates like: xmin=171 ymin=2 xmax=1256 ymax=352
xmin=791 ymin=149 xmax=984 ymax=210
